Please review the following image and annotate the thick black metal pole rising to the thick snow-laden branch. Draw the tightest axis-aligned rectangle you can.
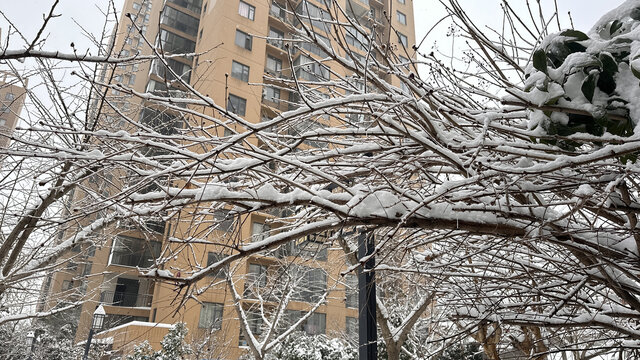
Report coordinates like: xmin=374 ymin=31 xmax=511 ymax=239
xmin=358 ymin=232 xmax=378 ymax=360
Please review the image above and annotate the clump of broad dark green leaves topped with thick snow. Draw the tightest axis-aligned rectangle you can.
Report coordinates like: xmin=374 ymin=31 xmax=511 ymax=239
xmin=512 ymin=1 xmax=640 ymax=152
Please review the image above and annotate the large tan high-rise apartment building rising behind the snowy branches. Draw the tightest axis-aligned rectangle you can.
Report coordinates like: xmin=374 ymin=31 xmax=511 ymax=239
xmin=40 ymin=0 xmax=415 ymax=359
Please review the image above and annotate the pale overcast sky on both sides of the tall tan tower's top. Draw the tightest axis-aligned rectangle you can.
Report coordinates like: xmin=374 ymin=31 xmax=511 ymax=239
xmin=0 ymin=0 xmax=624 ymax=73
